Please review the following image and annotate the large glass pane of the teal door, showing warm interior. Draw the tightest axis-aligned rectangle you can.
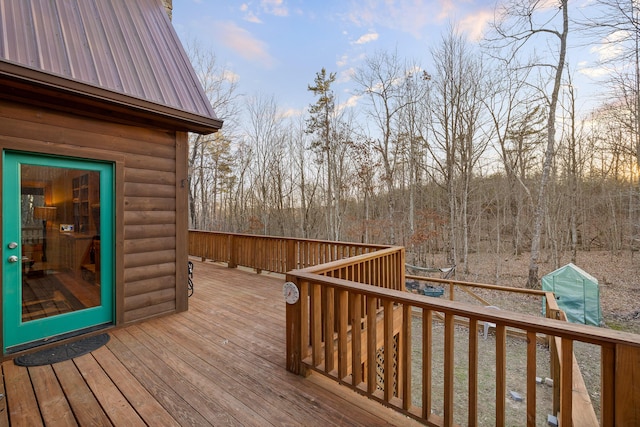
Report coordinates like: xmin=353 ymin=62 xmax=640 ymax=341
xmin=20 ymin=164 xmax=101 ymax=322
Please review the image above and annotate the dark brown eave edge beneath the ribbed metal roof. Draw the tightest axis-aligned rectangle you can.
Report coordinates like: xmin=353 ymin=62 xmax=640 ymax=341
xmin=0 ymin=60 xmax=223 ymax=135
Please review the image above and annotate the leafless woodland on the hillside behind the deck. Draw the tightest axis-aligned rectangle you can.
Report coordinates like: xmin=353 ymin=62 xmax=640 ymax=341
xmin=187 ymin=0 xmax=640 ymax=287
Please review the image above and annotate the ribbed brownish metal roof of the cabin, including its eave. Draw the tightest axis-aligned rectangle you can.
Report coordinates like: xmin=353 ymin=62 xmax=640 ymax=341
xmin=0 ymin=0 xmax=222 ymax=133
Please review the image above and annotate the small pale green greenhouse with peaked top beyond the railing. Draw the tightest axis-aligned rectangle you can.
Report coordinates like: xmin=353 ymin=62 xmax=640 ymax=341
xmin=542 ymin=263 xmax=602 ymax=326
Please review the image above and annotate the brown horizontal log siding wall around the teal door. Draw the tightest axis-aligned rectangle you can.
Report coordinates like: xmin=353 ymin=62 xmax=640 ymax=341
xmin=0 ymin=100 xmax=187 ymax=348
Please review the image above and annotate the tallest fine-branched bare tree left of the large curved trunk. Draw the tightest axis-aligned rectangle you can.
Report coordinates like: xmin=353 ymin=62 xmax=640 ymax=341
xmin=428 ymin=28 xmax=487 ymax=270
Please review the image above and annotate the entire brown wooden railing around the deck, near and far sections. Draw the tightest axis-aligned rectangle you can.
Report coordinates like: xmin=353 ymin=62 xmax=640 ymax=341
xmin=190 ymin=232 xmax=640 ymax=426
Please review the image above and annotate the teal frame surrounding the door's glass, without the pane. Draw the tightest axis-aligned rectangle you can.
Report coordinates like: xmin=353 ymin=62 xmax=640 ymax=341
xmin=2 ymin=151 xmax=115 ymax=354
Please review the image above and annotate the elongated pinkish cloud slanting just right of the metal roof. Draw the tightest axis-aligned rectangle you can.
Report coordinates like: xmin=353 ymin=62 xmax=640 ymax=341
xmin=214 ymin=21 xmax=274 ymax=68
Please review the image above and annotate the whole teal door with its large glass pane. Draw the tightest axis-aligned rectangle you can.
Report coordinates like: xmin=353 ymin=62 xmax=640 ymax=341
xmin=2 ymin=151 xmax=114 ymax=354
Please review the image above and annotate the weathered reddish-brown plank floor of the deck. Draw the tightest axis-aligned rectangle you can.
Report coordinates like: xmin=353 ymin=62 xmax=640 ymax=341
xmin=0 ymin=262 xmax=419 ymax=427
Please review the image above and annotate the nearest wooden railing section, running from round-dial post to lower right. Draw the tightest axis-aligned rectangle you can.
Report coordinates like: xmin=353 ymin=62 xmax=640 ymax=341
xmin=287 ymin=271 xmax=640 ymax=426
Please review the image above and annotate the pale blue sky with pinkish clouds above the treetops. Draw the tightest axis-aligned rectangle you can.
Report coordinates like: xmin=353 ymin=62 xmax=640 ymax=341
xmin=173 ymin=0 xmax=608 ymax=123
